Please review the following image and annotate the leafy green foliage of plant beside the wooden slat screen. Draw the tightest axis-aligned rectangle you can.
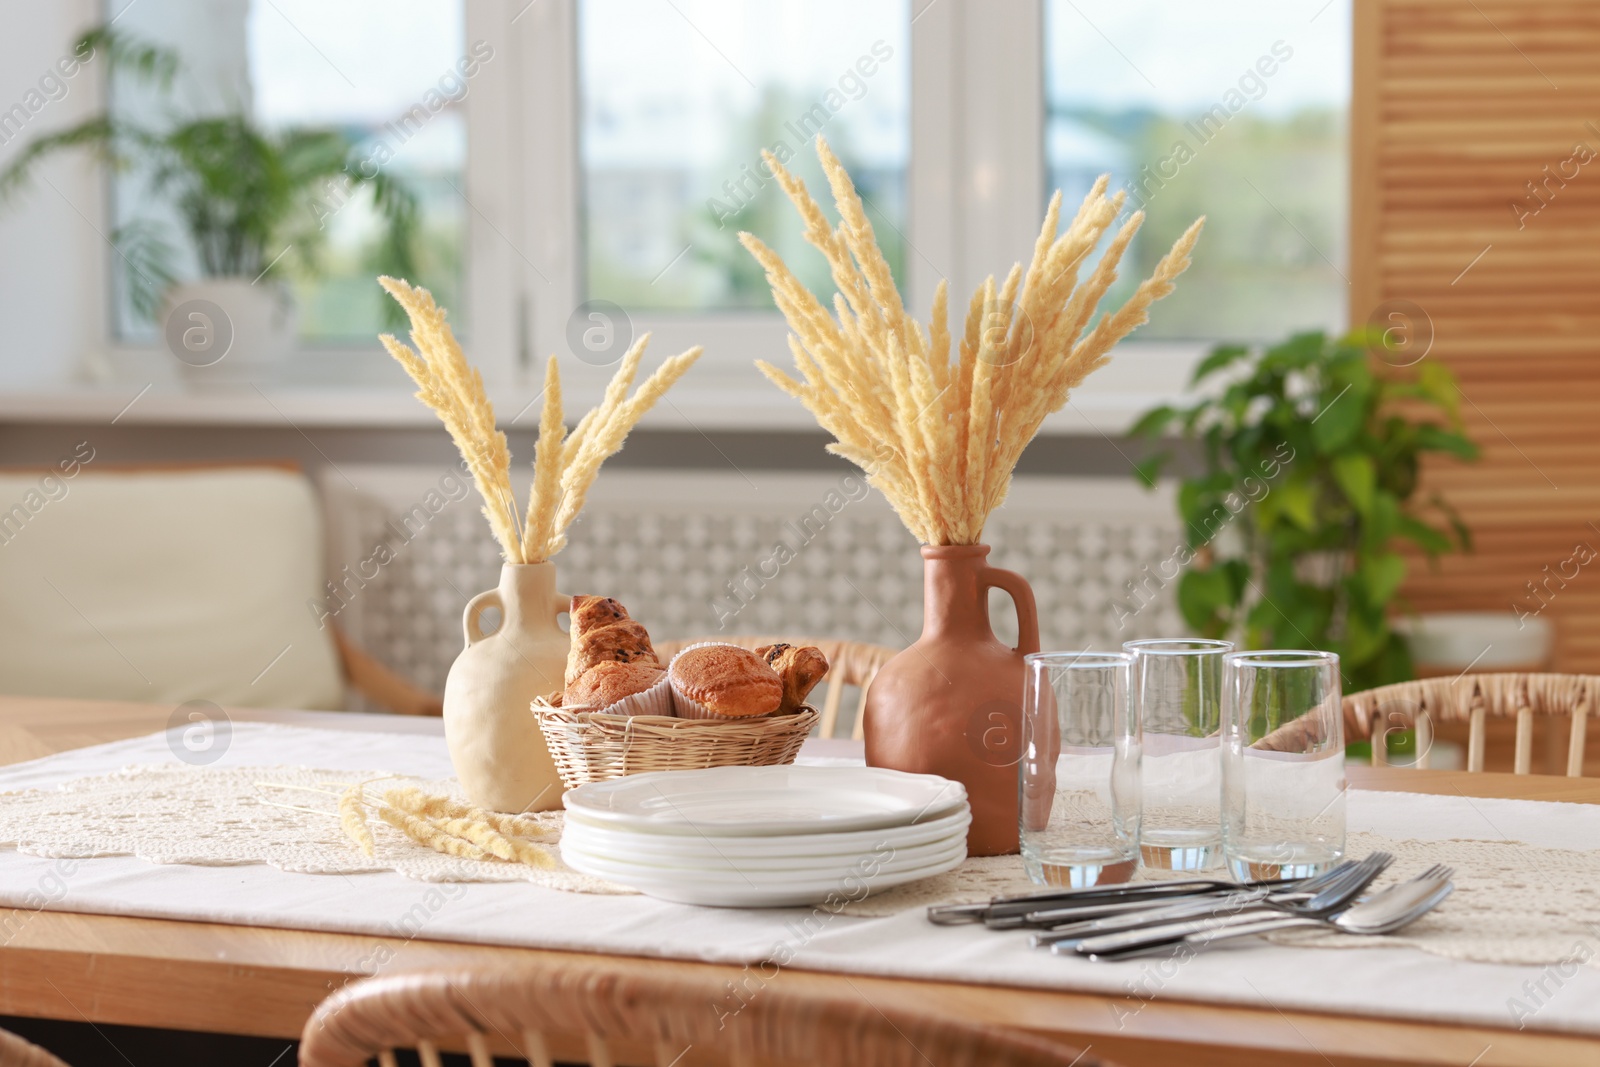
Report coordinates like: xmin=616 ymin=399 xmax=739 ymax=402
xmin=1131 ymin=333 xmax=1478 ymax=691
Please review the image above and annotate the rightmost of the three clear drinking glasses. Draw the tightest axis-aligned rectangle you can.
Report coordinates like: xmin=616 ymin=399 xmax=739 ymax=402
xmin=1222 ymin=651 xmax=1344 ymax=881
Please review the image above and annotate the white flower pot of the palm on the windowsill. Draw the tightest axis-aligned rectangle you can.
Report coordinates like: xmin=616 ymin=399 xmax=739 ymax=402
xmin=160 ymin=278 xmax=298 ymax=386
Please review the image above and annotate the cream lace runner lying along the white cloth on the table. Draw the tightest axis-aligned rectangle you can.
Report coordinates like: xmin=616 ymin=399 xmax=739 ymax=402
xmin=0 ymin=765 xmax=1600 ymax=968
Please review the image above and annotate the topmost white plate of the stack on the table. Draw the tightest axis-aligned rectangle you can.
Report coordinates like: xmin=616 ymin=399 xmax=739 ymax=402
xmin=563 ymin=766 xmax=966 ymax=837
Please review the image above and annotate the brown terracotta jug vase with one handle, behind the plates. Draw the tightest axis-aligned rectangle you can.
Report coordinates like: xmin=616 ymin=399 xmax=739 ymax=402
xmin=866 ymin=544 xmax=1038 ymax=856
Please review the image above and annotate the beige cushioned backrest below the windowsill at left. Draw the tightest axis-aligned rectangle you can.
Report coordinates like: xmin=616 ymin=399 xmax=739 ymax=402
xmin=0 ymin=463 xmax=342 ymax=707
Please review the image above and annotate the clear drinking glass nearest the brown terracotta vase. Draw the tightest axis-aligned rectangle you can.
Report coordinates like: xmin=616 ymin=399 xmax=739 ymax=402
xmin=1018 ymin=653 xmax=1139 ymax=886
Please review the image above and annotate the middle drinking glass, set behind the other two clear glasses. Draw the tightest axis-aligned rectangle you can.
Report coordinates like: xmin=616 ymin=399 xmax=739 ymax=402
xmin=1122 ymin=638 xmax=1234 ymax=870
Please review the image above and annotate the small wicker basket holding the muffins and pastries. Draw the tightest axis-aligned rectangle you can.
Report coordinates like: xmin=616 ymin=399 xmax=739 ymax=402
xmin=533 ymin=704 xmax=818 ymax=789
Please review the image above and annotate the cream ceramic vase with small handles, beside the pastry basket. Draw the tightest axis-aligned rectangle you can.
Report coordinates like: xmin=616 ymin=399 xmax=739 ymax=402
xmin=445 ymin=563 xmax=571 ymax=813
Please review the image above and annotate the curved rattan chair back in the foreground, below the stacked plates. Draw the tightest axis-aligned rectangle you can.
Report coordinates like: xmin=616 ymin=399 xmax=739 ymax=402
xmin=301 ymin=960 xmax=1099 ymax=1067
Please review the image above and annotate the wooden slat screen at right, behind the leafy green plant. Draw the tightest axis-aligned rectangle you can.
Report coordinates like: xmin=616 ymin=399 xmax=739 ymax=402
xmin=1350 ymin=0 xmax=1600 ymax=672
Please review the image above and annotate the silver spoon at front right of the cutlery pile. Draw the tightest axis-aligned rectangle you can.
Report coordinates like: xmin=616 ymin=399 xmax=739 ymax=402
xmin=1051 ymin=865 xmax=1454 ymax=961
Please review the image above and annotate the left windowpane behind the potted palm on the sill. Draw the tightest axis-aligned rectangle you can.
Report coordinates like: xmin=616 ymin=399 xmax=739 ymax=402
xmin=109 ymin=0 xmax=464 ymax=344
